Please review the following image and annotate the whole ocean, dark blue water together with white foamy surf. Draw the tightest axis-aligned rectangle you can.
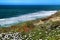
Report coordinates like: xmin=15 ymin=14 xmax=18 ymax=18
xmin=0 ymin=5 xmax=60 ymax=25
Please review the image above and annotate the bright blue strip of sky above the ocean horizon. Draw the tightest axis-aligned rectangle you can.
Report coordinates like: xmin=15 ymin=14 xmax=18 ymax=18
xmin=0 ymin=0 xmax=60 ymax=5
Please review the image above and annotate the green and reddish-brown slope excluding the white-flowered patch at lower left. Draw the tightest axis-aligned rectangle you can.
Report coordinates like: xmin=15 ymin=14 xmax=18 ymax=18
xmin=0 ymin=12 xmax=60 ymax=40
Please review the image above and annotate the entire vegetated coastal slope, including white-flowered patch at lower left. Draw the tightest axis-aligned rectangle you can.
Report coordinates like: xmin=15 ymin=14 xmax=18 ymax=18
xmin=0 ymin=12 xmax=60 ymax=40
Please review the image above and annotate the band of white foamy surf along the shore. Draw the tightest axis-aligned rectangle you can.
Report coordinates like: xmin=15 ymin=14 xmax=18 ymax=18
xmin=0 ymin=11 xmax=57 ymax=26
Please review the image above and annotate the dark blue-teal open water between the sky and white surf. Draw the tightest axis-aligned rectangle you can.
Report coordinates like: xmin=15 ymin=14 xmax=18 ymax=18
xmin=0 ymin=5 xmax=60 ymax=19
